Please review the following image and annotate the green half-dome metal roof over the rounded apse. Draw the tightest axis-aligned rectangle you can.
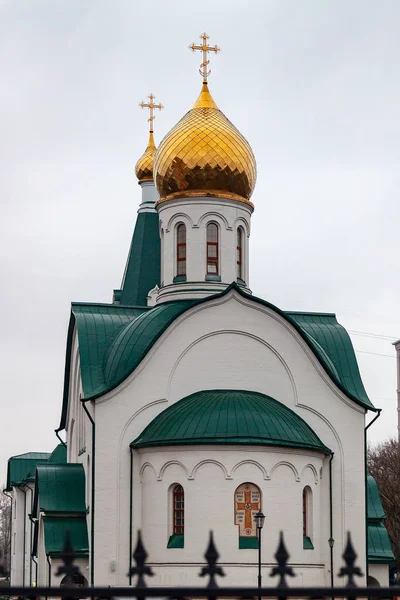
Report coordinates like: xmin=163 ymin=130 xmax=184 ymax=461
xmin=131 ymin=390 xmax=330 ymax=454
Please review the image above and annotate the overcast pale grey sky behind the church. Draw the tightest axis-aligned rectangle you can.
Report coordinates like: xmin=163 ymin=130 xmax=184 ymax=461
xmin=0 ymin=0 xmax=400 ymax=481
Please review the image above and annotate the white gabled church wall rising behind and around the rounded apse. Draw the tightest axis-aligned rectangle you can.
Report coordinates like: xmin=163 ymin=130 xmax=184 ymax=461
xmin=91 ymin=292 xmax=364 ymax=585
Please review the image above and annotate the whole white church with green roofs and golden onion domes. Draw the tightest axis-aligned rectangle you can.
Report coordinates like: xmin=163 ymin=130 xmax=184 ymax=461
xmin=3 ymin=38 xmax=393 ymax=586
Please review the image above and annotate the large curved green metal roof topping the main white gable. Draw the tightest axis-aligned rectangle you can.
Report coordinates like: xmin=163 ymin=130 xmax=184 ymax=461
xmin=58 ymin=283 xmax=376 ymax=430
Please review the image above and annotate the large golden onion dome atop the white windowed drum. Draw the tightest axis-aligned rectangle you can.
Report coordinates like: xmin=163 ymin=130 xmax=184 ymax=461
xmin=154 ymin=83 xmax=256 ymax=205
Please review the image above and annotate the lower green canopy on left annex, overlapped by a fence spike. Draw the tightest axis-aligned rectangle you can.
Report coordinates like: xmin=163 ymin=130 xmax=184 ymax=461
xmin=43 ymin=517 xmax=89 ymax=558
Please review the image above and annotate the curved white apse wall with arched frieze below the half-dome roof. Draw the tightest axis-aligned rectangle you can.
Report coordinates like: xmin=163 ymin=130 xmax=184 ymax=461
xmin=140 ymin=446 xmax=328 ymax=584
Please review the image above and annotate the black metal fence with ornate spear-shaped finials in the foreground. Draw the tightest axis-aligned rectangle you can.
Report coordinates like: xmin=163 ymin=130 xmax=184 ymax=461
xmin=0 ymin=532 xmax=400 ymax=600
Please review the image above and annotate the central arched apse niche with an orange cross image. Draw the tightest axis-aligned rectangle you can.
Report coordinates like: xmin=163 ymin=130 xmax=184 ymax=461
xmin=235 ymin=483 xmax=261 ymax=549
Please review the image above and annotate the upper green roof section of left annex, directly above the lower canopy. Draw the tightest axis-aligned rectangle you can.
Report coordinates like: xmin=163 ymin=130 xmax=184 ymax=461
xmin=32 ymin=463 xmax=86 ymax=516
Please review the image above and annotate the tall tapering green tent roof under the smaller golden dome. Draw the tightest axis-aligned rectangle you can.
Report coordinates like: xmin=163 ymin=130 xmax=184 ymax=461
xmin=120 ymin=211 xmax=161 ymax=307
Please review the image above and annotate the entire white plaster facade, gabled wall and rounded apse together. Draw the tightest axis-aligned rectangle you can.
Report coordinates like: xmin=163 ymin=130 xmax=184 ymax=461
xmin=67 ymin=290 xmax=365 ymax=585
